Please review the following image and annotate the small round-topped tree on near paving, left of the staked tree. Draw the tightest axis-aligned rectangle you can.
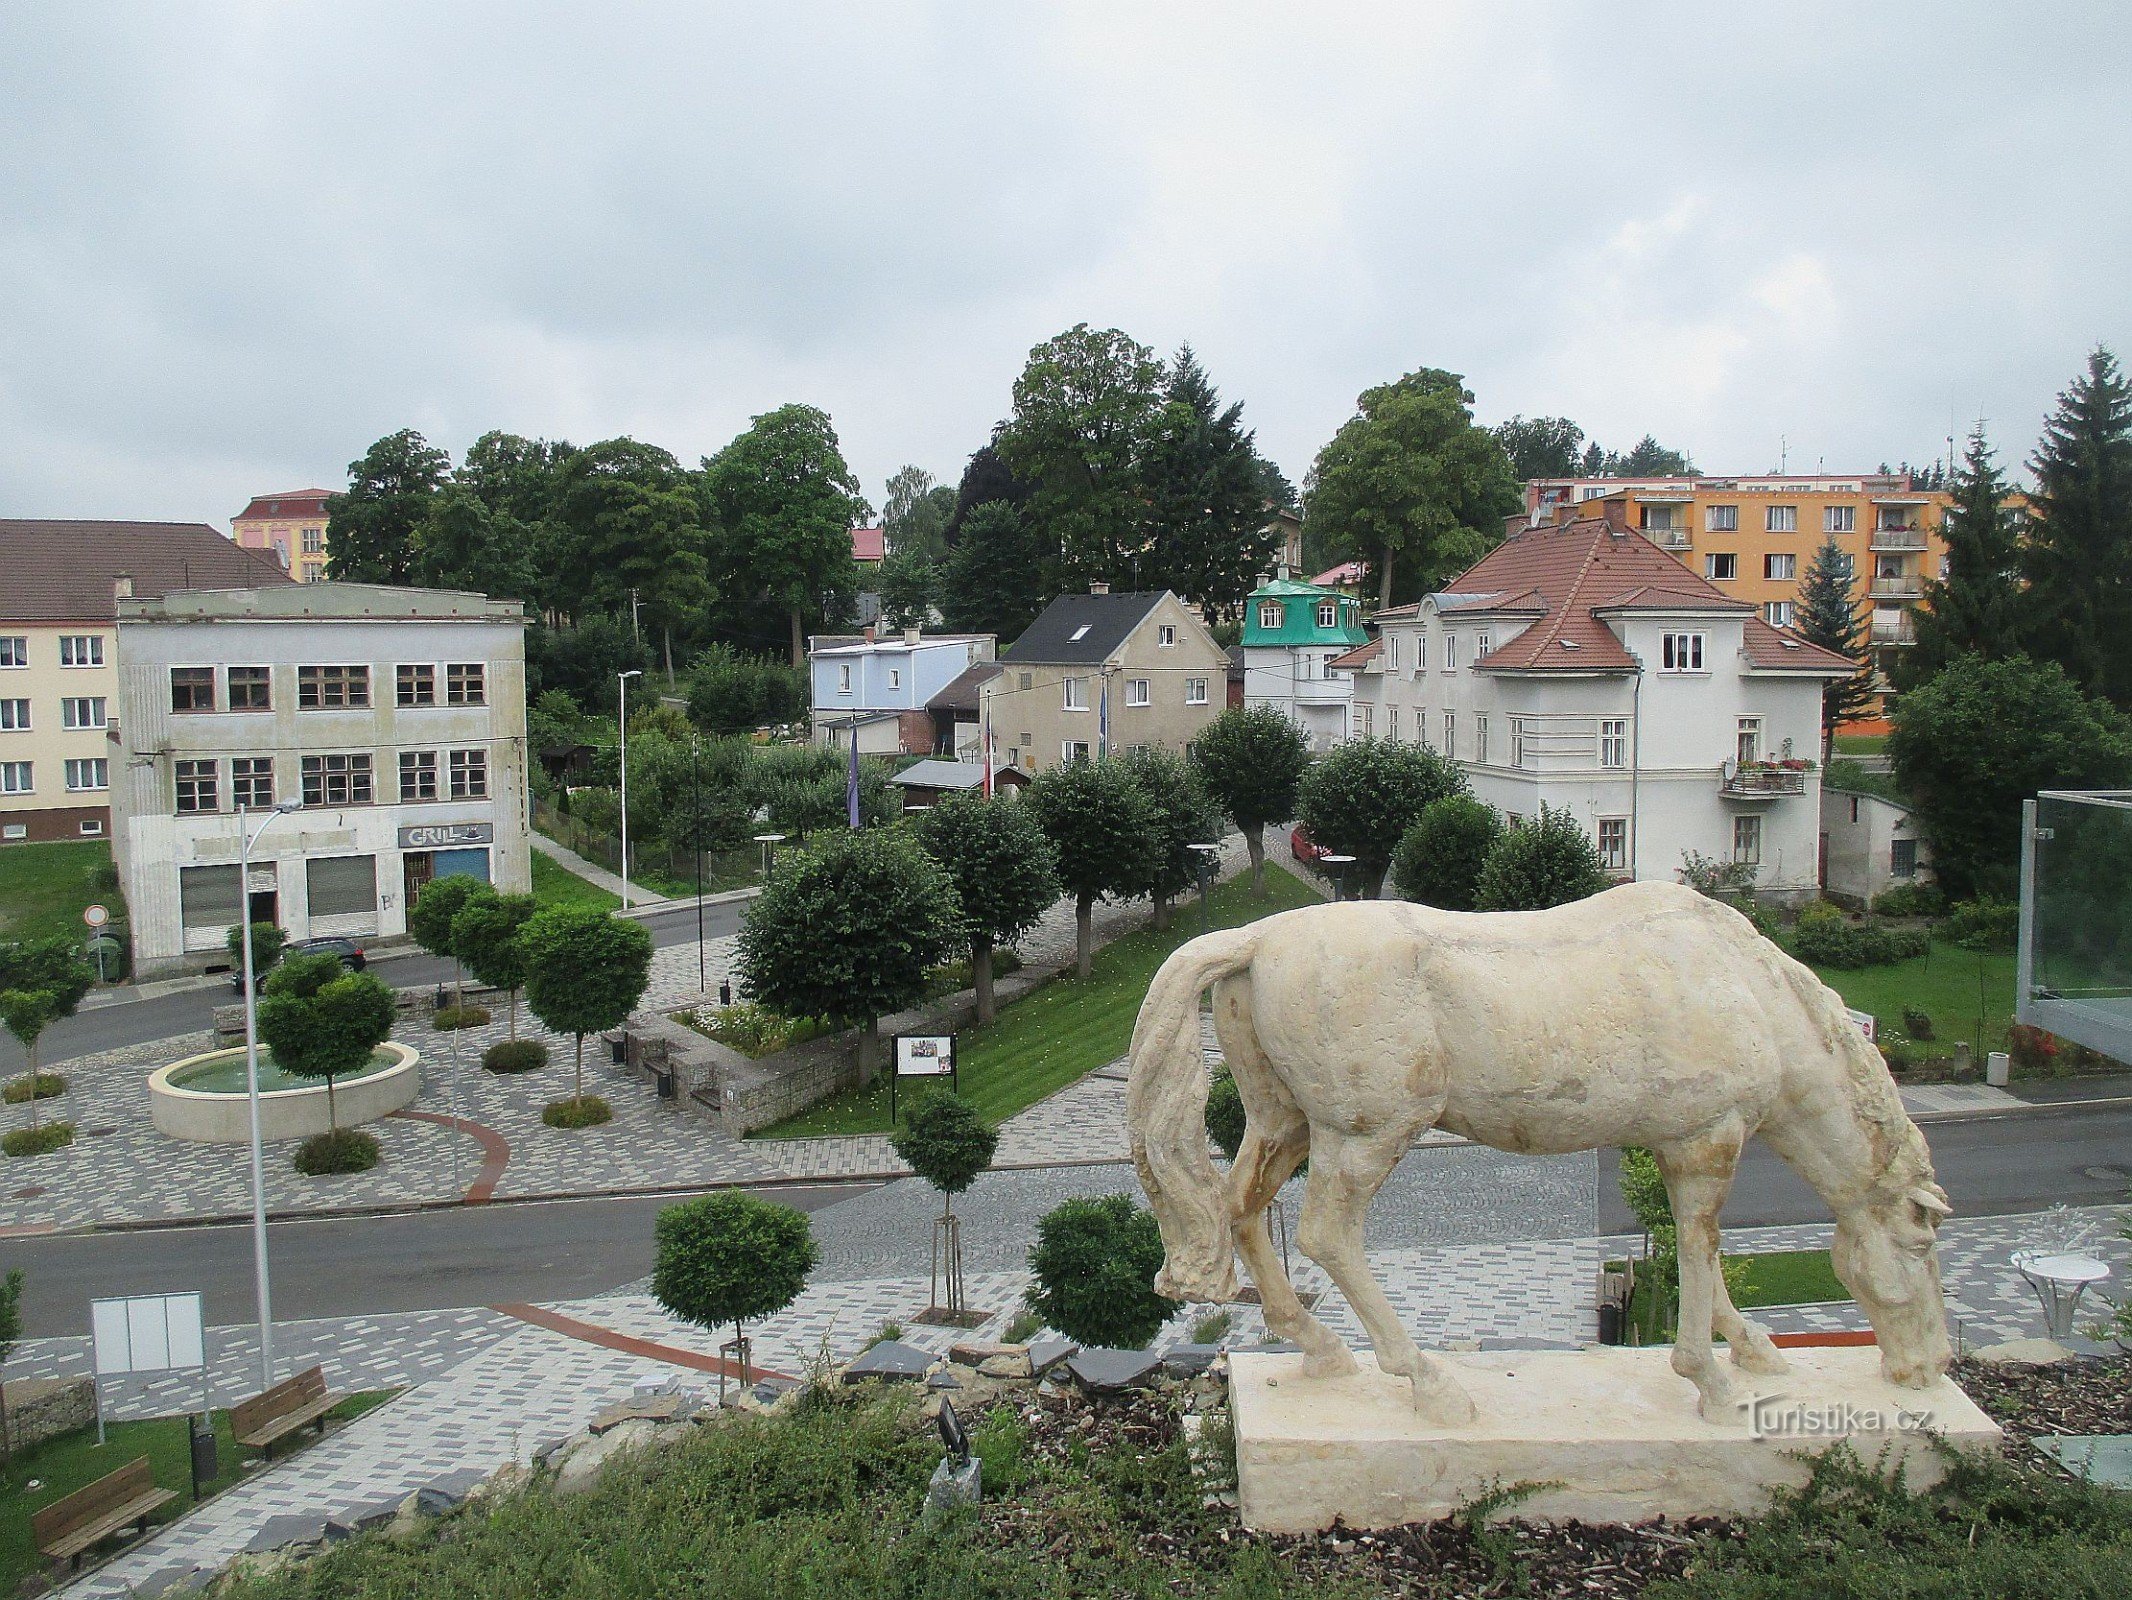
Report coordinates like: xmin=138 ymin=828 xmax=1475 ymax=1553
xmin=652 ymin=1188 xmax=819 ymax=1382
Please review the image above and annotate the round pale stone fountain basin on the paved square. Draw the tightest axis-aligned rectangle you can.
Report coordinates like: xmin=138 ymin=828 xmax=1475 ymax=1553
xmin=147 ymin=1041 xmax=422 ymax=1143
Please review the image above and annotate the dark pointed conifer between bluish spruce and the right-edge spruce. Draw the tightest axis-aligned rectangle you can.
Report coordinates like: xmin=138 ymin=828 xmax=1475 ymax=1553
xmin=1897 ymin=422 xmax=2021 ymax=689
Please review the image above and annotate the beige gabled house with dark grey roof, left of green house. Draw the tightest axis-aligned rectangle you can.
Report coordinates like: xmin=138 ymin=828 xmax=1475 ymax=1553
xmin=976 ymin=585 xmax=1228 ymax=772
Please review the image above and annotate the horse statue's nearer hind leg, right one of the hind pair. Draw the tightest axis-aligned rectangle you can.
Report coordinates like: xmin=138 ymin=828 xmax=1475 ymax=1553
xmin=1301 ymin=1111 xmax=1473 ymax=1427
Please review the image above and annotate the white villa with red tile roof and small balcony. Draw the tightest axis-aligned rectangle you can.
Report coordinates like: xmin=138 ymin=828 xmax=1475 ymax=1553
xmin=1333 ymin=503 xmax=1853 ymax=898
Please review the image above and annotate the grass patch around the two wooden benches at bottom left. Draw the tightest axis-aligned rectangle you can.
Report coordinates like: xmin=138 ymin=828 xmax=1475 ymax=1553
xmin=0 ymin=1389 xmax=394 ymax=1594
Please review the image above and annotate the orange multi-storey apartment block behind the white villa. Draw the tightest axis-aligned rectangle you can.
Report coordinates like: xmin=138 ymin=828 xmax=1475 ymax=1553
xmin=1524 ymin=474 xmax=1951 ymax=708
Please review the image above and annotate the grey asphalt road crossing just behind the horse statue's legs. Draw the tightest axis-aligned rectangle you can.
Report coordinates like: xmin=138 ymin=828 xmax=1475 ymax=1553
xmin=0 ymin=1107 xmax=2132 ymax=1333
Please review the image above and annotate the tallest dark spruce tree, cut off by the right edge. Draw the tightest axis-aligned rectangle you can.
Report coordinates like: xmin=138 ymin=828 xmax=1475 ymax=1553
xmin=2021 ymin=346 xmax=2132 ymax=706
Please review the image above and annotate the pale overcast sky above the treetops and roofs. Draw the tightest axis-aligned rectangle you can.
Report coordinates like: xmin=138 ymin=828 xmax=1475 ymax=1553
xmin=0 ymin=0 xmax=2132 ymax=527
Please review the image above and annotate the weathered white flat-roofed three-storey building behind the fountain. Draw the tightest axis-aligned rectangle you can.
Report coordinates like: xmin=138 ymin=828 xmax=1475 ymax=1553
xmin=111 ymin=582 xmax=531 ymax=975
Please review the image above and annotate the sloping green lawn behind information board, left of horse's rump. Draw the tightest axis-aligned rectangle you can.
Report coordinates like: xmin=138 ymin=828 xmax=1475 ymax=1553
xmin=755 ymin=864 xmax=1322 ymax=1139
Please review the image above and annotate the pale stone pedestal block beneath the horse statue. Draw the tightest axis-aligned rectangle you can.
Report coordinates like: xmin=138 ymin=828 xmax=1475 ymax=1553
xmin=1230 ymin=1346 xmax=2000 ymax=1534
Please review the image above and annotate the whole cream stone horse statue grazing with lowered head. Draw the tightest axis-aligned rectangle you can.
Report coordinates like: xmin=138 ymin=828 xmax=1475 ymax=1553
xmin=1126 ymin=883 xmax=1949 ymax=1425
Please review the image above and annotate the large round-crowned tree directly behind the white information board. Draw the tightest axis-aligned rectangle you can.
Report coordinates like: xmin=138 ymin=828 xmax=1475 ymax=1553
xmin=740 ymin=828 xmax=964 ymax=1079
